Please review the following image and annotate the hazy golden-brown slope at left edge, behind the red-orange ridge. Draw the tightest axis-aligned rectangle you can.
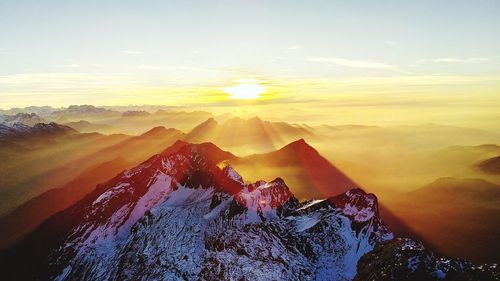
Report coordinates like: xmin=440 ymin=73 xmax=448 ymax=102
xmin=0 ymin=133 xmax=128 ymax=213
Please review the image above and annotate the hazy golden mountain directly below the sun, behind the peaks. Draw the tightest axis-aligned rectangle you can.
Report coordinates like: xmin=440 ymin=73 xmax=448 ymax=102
xmin=186 ymin=117 xmax=315 ymax=155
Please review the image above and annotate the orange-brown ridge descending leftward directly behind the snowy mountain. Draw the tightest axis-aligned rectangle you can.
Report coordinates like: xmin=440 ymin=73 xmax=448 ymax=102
xmin=0 ymin=127 xmax=185 ymax=248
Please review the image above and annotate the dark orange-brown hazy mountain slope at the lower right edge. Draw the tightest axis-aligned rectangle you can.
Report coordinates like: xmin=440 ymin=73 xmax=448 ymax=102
xmin=388 ymin=178 xmax=500 ymax=263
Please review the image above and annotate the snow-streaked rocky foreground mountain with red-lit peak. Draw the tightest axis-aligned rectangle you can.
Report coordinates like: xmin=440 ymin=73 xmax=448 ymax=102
xmin=0 ymin=142 xmax=392 ymax=280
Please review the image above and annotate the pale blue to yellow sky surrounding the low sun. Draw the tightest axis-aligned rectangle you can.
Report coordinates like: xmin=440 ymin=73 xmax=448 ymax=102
xmin=0 ymin=0 xmax=500 ymax=126
